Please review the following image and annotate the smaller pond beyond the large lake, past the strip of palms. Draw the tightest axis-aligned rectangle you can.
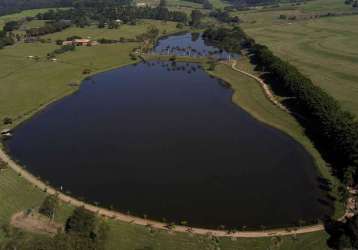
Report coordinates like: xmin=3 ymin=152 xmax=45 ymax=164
xmin=154 ymin=33 xmax=239 ymax=59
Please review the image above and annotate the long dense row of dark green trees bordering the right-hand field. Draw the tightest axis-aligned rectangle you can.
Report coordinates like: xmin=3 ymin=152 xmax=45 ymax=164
xmin=252 ymin=44 xmax=358 ymax=185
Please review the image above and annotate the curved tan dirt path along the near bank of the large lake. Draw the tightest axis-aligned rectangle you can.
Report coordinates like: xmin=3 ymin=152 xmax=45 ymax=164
xmin=0 ymin=146 xmax=324 ymax=238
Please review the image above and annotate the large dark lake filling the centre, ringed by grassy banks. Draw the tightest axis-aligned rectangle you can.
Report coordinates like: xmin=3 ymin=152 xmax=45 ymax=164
xmin=7 ymin=62 xmax=330 ymax=228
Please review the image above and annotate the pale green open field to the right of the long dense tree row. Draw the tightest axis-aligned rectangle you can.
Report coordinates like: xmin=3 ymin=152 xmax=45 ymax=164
xmin=245 ymin=15 xmax=358 ymax=115
